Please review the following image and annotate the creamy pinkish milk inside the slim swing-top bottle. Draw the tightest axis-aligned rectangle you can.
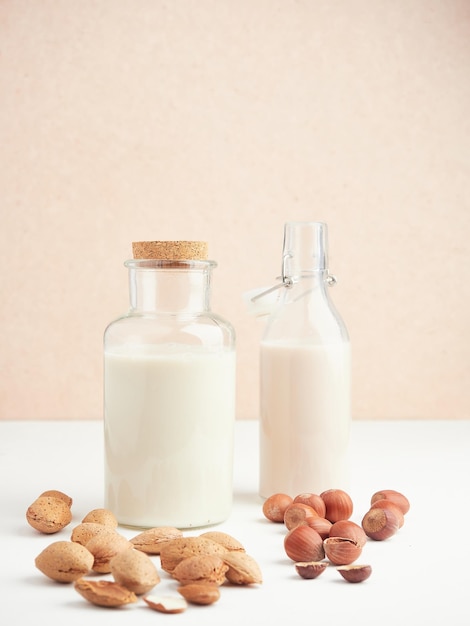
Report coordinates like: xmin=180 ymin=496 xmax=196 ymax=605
xmin=260 ymin=342 xmax=351 ymax=498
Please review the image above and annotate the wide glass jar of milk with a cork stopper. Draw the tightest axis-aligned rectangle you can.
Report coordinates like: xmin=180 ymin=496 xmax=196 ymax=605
xmin=104 ymin=241 xmax=235 ymax=528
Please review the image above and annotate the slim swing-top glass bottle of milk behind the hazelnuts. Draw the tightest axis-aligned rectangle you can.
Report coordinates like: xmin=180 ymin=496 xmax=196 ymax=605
xmin=259 ymin=222 xmax=351 ymax=498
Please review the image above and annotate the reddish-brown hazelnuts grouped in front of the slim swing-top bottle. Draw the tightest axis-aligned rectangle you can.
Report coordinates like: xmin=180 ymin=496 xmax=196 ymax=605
xmin=263 ymin=489 xmax=410 ymax=583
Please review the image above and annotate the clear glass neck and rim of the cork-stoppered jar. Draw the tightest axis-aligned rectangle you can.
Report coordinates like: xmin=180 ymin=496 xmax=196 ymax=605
xmin=125 ymin=259 xmax=216 ymax=315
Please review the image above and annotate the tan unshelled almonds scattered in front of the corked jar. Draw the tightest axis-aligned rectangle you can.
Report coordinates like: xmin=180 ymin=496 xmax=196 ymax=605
xmin=26 ymin=490 xmax=262 ymax=613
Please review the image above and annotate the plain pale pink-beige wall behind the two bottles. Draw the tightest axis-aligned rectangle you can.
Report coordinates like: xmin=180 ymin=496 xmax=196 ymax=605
xmin=0 ymin=0 xmax=470 ymax=419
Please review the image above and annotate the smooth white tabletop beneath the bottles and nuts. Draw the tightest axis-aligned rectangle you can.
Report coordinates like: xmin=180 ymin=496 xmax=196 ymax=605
xmin=0 ymin=414 xmax=470 ymax=626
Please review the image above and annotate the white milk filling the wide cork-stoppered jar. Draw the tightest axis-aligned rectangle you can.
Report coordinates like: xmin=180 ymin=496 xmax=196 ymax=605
xmin=104 ymin=346 xmax=235 ymax=528
